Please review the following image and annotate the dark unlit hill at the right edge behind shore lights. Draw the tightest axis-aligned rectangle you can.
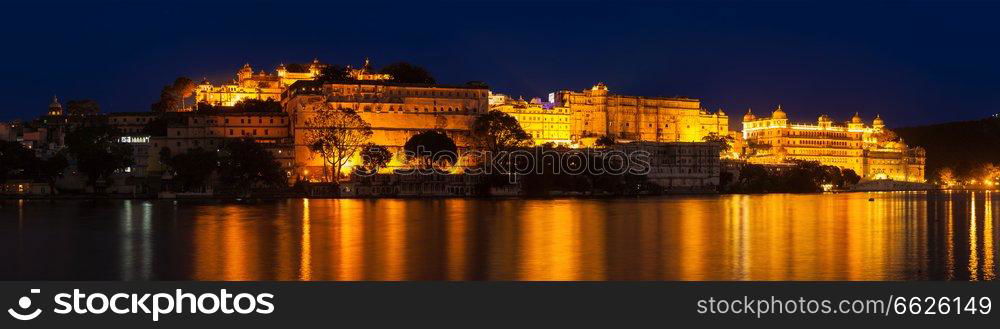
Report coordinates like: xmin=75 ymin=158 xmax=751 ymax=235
xmin=893 ymin=117 xmax=1000 ymax=179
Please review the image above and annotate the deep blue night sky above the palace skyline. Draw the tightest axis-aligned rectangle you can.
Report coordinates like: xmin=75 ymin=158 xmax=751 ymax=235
xmin=0 ymin=1 xmax=1000 ymax=129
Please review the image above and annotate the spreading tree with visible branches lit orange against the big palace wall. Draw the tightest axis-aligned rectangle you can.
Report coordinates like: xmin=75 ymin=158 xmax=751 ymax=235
xmin=305 ymin=105 xmax=372 ymax=180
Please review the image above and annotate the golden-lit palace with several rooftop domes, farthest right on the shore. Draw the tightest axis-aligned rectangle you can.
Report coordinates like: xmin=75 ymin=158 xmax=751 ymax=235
xmin=743 ymin=106 xmax=926 ymax=182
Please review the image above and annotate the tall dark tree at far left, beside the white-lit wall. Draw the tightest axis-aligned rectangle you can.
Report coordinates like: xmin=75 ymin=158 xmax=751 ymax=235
xmin=66 ymin=126 xmax=132 ymax=185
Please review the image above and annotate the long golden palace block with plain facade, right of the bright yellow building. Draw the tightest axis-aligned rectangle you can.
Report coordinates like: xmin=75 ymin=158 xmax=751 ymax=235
xmin=550 ymin=83 xmax=729 ymax=142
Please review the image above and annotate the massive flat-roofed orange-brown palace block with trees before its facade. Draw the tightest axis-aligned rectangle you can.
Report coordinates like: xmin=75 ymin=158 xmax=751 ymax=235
xmin=282 ymin=80 xmax=489 ymax=179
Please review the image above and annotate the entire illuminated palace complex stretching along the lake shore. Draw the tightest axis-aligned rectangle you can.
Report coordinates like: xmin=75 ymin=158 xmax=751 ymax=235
xmin=0 ymin=60 xmax=925 ymax=195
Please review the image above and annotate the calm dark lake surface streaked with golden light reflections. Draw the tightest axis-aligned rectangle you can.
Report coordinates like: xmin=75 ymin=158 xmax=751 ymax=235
xmin=0 ymin=192 xmax=1000 ymax=280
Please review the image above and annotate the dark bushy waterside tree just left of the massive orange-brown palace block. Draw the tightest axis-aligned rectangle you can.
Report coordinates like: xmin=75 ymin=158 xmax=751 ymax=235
xmin=219 ymin=139 xmax=288 ymax=195
